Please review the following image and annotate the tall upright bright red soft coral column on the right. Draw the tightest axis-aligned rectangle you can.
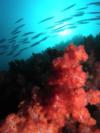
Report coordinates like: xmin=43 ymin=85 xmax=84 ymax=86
xmin=49 ymin=45 xmax=100 ymax=126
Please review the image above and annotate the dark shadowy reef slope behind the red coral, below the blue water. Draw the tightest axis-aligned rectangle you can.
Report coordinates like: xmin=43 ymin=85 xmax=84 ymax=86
xmin=0 ymin=34 xmax=100 ymax=120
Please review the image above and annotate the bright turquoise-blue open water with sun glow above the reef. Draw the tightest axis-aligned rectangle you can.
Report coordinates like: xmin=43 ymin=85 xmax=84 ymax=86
xmin=0 ymin=0 xmax=100 ymax=69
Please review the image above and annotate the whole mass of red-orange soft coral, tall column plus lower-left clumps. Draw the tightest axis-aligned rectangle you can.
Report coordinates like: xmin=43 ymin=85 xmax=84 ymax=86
xmin=0 ymin=44 xmax=100 ymax=133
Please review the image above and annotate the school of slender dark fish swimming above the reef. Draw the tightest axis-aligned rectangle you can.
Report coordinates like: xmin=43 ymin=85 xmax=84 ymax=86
xmin=0 ymin=1 xmax=100 ymax=57
